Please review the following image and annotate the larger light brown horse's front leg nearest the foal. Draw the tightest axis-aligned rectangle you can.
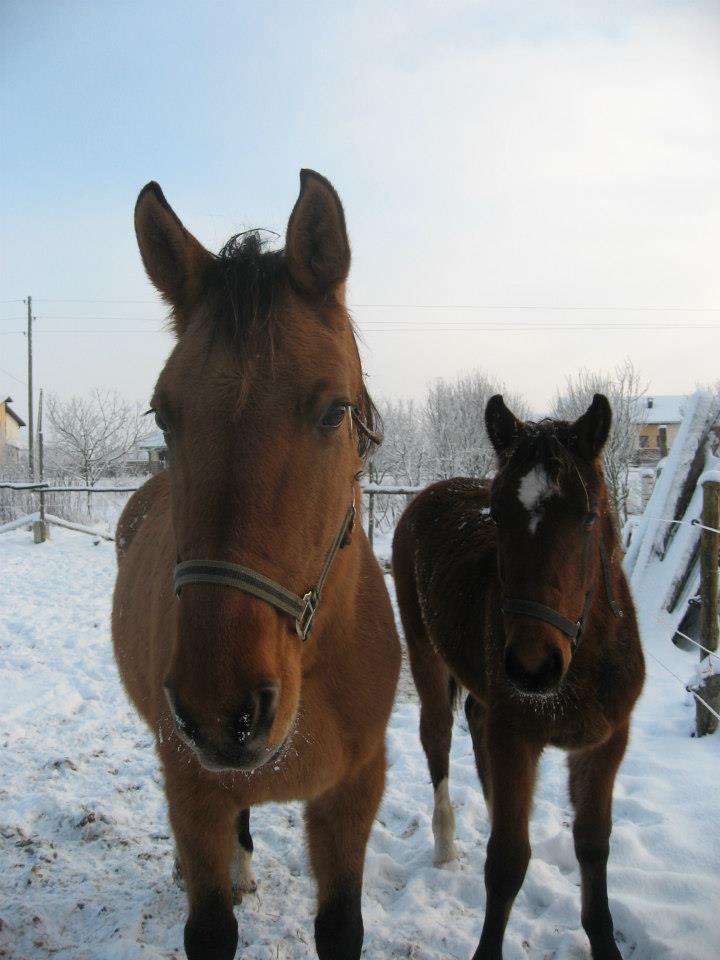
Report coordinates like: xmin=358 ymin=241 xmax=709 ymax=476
xmin=305 ymin=746 xmax=385 ymax=960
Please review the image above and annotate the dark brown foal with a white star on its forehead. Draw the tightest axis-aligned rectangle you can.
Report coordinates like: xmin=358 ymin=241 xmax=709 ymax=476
xmin=393 ymin=395 xmax=644 ymax=960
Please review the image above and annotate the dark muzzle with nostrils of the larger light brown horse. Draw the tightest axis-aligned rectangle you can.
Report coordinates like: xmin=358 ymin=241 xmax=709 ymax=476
xmin=164 ymin=681 xmax=282 ymax=770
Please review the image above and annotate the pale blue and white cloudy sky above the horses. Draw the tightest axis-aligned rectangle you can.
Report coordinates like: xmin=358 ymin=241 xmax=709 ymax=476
xmin=0 ymin=0 xmax=720 ymax=424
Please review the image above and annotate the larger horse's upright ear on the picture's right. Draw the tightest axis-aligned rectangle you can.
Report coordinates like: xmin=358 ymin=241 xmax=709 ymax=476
xmin=285 ymin=170 xmax=350 ymax=296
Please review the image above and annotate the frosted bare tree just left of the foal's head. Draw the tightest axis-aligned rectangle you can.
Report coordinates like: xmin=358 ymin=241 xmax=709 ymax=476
xmin=423 ymin=370 xmax=529 ymax=478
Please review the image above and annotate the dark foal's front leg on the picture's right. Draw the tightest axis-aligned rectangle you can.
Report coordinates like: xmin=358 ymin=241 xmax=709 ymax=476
xmin=568 ymin=726 xmax=628 ymax=960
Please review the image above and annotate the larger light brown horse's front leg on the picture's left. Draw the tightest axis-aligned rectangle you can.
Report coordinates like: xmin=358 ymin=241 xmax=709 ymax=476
xmin=166 ymin=780 xmax=238 ymax=960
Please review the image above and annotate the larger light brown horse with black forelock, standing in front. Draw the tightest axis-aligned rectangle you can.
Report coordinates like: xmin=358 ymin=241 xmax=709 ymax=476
xmin=113 ymin=170 xmax=400 ymax=960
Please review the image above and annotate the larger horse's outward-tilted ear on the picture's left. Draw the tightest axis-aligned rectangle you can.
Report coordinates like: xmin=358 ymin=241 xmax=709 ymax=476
xmin=135 ymin=181 xmax=213 ymax=333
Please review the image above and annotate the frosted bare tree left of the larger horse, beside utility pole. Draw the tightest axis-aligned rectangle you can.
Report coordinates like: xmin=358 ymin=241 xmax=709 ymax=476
xmin=47 ymin=388 xmax=147 ymax=513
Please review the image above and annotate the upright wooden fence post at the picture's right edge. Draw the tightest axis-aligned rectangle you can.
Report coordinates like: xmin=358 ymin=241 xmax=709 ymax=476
xmin=695 ymin=480 xmax=720 ymax=737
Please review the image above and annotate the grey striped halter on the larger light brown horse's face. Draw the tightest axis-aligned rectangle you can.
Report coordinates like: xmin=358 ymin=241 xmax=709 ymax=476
xmin=173 ymin=498 xmax=355 ymax=640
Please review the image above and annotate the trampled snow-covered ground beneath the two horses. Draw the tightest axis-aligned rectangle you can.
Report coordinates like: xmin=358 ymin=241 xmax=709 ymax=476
xmin=0 ymin=529 xmax=720 ymax=960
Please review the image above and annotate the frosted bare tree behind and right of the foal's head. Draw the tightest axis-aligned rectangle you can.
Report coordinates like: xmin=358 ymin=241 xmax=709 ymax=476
xmin=552 ymin=359 xmax=647 ymax=521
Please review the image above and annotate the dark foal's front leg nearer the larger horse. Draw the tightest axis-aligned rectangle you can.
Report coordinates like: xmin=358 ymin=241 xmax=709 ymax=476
xmin=473 ymin=718 xmax=542 ymax=960
